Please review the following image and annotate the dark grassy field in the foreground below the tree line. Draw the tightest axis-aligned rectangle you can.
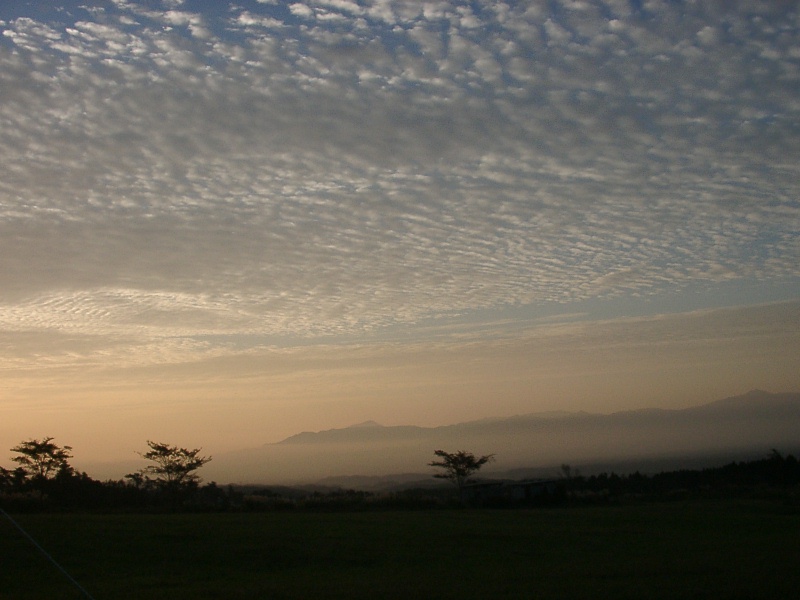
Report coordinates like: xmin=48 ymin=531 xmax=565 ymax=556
xmin=0 ymin=501 xmax=800 ymax=600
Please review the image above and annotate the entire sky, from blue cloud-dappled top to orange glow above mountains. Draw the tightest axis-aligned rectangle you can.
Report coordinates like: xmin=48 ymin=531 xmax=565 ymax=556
xmin=0 ymin=0 xmax=800 ymax=474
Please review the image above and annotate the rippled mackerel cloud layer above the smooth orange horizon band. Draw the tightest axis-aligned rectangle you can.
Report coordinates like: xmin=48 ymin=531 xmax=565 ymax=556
xmin=0 ymin=0 xmax=800 ymax=464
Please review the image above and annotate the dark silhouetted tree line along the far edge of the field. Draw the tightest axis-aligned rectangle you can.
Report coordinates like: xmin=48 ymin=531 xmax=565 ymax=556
xmin=0 ymin=437 xmax=800 ymax=511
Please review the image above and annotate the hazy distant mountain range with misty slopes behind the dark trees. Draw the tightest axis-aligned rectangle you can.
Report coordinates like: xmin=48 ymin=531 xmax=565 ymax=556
xmin=202 ymin=390 xmax=800 ymax=488
